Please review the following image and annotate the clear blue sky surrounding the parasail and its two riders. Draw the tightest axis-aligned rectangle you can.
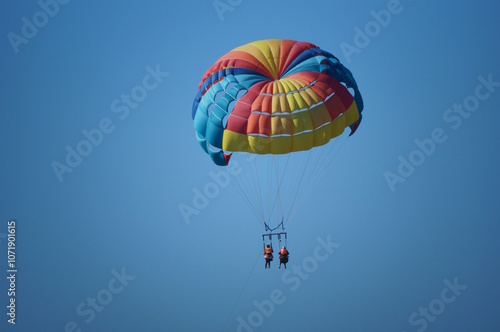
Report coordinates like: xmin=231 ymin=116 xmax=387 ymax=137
xmin=0 ymin=0 xmax=500 ymax=331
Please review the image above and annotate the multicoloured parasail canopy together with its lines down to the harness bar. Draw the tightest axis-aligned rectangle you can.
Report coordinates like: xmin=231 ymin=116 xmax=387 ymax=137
xmin=192 ymin=39 xmax=363 ymax=246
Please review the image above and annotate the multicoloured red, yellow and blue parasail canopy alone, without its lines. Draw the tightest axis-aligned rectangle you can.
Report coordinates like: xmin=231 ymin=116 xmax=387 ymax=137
xmin=192 ymin=39 xmax=363 ymax=166
